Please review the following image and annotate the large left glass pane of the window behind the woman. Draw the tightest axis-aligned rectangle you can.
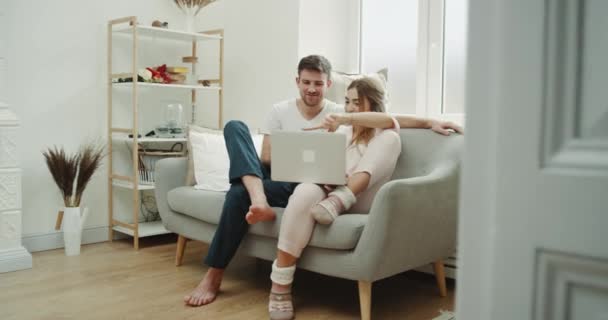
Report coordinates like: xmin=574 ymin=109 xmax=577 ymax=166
xmin=361 ymin=0 xmax=419 ymax=114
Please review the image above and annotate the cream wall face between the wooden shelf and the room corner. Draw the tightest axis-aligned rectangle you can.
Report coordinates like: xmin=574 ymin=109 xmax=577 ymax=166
xmin=197 ymin=0 xmax=299 ymax=128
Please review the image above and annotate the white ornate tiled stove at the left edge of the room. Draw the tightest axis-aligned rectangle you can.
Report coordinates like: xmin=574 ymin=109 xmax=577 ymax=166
xmin=0 ymin=102 xmax=32 ymax=273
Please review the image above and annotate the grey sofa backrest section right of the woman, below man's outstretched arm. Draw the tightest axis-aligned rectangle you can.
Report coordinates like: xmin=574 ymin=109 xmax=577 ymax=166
xmin=391 ymin=129 xmax=464 ymax=179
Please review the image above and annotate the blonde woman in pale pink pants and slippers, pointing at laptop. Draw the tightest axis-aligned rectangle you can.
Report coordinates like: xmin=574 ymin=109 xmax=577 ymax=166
xmin=268 ymin=78 xmax=401 ymax=320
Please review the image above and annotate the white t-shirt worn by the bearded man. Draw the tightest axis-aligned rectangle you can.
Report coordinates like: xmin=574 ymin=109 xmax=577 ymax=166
xmin=260 ymin=98 xmax=344 ymax=134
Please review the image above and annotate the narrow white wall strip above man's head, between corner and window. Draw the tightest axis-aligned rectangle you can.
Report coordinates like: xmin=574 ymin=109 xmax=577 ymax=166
xmin=298 ymin=0 xmax=360 ymax=73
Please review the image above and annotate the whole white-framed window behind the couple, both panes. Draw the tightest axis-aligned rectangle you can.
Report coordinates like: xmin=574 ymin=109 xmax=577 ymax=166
xmin=361 ymin=0 xmax=467 ymax=124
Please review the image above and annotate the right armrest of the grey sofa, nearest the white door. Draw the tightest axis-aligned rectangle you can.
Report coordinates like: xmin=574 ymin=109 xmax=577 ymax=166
xmin=355 ymin=163 xmax=458 ymax=281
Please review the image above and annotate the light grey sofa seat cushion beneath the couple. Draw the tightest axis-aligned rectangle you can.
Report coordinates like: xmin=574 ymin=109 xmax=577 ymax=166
xmin=167 ymin=186 xmax=367 ymax=250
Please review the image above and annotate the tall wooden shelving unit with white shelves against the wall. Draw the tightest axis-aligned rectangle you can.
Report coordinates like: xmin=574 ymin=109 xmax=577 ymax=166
xmin=107 ymin=17 xmax=224 ymax=249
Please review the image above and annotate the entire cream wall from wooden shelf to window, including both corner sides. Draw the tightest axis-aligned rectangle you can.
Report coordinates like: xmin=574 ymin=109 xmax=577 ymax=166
xmin=198 ymin=0 xmax=360 ymax=128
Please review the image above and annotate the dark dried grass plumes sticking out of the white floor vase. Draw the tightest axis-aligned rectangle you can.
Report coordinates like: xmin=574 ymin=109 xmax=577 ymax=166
xmin=42 ymin=143 xmax=104 ymax=207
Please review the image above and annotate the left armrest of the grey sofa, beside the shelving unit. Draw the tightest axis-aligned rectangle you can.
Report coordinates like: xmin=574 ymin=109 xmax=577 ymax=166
xmin=154 ymin=158 xmax=188 ymax=220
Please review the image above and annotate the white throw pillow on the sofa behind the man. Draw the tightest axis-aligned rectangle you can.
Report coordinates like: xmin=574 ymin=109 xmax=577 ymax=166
xmin=190 ymin=130 xmax=263 ymax=191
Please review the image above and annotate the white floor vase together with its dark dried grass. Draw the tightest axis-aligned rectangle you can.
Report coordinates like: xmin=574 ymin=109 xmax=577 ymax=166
xmin=42 ymin=143 xmax=104 ymax=256
